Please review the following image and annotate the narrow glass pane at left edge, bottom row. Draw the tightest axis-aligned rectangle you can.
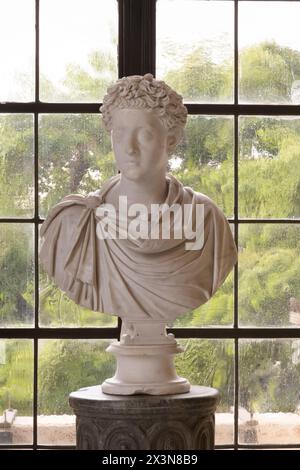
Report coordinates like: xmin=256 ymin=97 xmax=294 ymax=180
xmin=0 ymin=339 xmax=33 ymax=445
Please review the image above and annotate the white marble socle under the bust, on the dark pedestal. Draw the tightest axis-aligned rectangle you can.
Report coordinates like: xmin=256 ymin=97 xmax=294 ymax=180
xmin=102 ymin=320 xmax=190 ymax=395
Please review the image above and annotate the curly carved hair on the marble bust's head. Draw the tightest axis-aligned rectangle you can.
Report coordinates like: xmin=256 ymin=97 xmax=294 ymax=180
xmin=100 ymin=73 xmax=187 ymax=150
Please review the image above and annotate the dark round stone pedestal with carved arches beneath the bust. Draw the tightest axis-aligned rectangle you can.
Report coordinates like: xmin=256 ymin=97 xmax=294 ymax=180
xmin=69 ymin=386 xmax=219 ymax=450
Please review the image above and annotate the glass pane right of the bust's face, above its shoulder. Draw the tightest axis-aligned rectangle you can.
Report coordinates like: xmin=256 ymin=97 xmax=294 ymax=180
xmin=169 ymin=116 xmax=233 ymax=217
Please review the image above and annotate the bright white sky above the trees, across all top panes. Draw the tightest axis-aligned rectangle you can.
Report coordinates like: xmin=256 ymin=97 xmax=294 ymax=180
xmin=0 ymin=0 xmax=300 ymax=101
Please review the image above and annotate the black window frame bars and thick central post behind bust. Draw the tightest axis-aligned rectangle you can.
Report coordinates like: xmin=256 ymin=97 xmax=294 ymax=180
xmin=0 ymin=0 xmax=300 ymax=450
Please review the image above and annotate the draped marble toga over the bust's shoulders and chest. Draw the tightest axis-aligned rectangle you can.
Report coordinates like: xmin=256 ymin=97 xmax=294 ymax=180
xmin=40 ymin=175 xmax=237 ymax=321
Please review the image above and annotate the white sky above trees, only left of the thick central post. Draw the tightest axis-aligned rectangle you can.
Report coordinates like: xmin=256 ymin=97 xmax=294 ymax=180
xmin=0 ymin=0 xmax=118 ymax=101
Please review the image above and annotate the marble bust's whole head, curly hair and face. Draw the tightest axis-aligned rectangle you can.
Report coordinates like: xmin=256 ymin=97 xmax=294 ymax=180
xmin=100 ymin=74 xmax=187 ymax=178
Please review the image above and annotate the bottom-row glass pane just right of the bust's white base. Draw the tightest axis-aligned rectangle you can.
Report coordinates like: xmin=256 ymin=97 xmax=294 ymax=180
xmin=175 ymin=339 xmax=234 ymax=445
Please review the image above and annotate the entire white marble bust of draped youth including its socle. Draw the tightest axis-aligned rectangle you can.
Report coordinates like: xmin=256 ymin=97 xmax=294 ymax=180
xmin=40 ymin=74 xmax=237 ymax=395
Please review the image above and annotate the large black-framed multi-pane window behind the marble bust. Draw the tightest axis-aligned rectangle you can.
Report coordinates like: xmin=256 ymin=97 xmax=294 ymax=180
xmin=0 ymin=0 xmax=300 ymax=449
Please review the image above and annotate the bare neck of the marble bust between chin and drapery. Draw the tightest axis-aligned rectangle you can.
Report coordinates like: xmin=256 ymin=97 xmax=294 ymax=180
xmin=118 ymin=172 xmax=168 ymax=205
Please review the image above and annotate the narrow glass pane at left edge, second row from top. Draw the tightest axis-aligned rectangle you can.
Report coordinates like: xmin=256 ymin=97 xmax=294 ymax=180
xmin=0 ymin=114 xmax=33 ymax=217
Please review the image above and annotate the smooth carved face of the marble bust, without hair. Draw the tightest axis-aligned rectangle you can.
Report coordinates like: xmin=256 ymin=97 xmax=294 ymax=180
xmin=111 ymin=108 xmax=175 ymax=180
